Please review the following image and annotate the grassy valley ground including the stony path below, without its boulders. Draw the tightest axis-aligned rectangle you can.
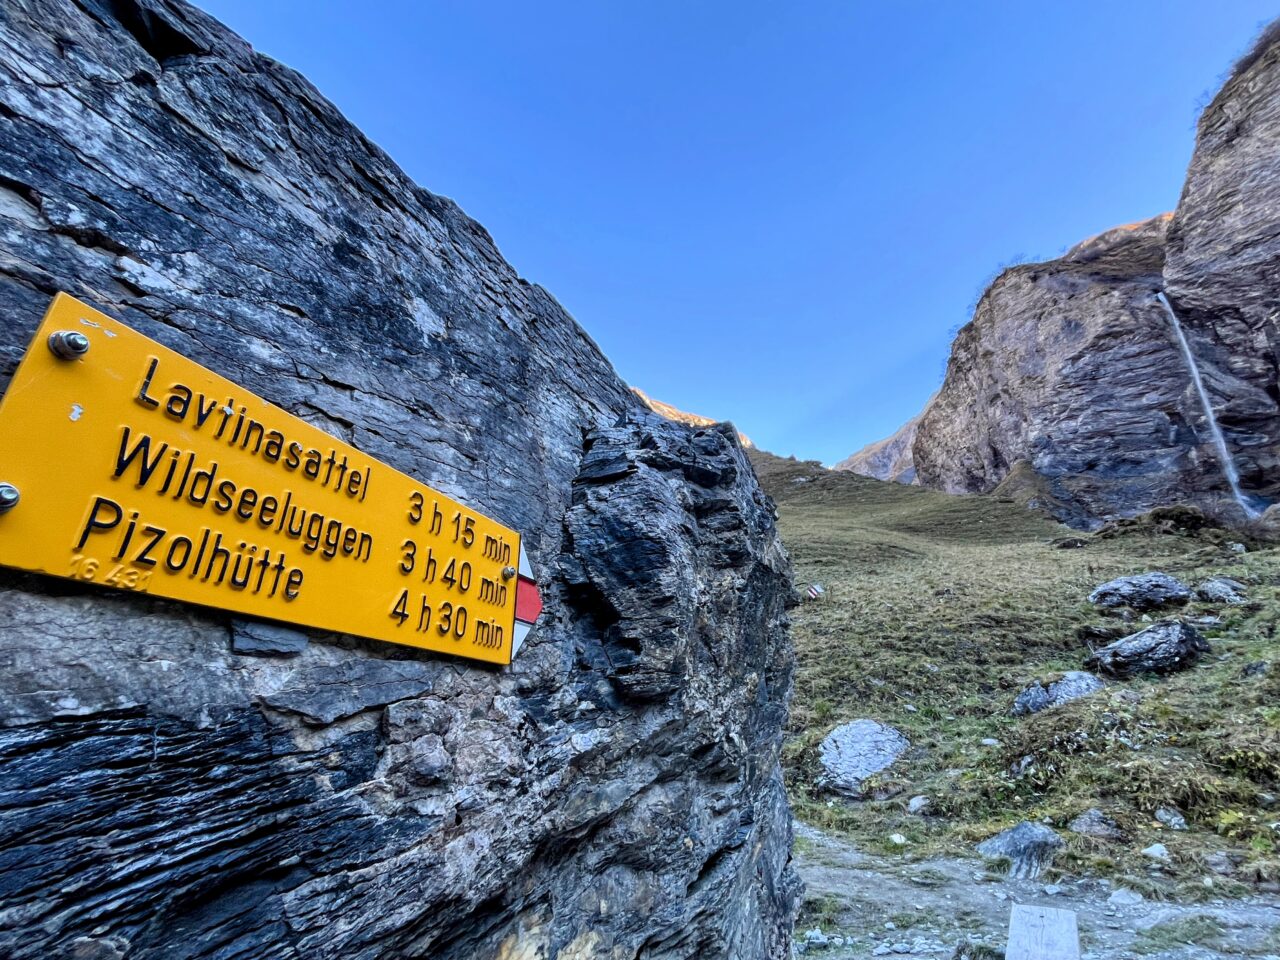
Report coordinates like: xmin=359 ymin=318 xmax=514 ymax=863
xmin=753 ymin=452 xmax=1280 ymax=957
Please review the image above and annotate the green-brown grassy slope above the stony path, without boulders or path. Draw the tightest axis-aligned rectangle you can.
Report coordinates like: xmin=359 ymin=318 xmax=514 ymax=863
xmin=753 ymin=453 xmax=1280 ymax=897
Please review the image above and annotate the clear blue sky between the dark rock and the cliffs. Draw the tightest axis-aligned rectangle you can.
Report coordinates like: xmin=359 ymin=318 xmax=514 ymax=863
xmin=202 ymin=0 xmax=1276 ymax=463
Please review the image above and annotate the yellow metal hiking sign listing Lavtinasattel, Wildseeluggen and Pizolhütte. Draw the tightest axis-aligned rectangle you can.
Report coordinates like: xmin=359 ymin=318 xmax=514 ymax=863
xmin=0 ymin=293 xmax=520 ymax=663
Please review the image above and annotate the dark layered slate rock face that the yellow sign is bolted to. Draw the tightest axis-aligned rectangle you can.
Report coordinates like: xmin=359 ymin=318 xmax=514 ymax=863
xmin=0 ymin=0 xmax=796 ymax=960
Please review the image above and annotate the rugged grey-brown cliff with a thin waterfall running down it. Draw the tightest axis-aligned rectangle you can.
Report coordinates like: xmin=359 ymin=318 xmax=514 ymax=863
xmin=851 ymin=27 xmax=1280 ymax=527
